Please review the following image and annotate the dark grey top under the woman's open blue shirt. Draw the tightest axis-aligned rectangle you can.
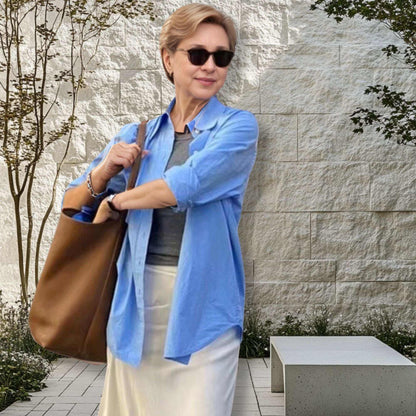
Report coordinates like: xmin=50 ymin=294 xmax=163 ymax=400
xmin=146 ymin=126 xmax=193 ymax=266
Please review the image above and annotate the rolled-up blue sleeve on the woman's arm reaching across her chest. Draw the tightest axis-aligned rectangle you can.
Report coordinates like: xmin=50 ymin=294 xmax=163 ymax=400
xmin=162 ymin=110 xmax=258 ymax=212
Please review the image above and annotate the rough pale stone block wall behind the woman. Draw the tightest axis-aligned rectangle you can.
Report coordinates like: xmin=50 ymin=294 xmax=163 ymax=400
xmin=0 ymin=0 xmax=416 ymax=325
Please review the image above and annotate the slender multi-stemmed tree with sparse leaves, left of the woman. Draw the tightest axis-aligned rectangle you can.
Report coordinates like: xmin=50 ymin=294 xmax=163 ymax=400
xmin=0 ymin=0 xmax=155 ymax=303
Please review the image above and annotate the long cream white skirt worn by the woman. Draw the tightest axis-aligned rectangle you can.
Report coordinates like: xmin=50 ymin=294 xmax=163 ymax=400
xmin=98 ymin=264 xmax=240 ymax=416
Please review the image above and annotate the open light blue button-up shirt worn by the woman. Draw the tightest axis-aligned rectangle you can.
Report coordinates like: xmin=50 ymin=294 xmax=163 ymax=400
xmin=63 ymin=96 xmax=258 ymax=367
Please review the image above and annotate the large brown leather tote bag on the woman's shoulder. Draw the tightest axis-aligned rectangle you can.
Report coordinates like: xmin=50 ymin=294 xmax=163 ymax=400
xmin=29 ymin=121 xmax=147 ymax=363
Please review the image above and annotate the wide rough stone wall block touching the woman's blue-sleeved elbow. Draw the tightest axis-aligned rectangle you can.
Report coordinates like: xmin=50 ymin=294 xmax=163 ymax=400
xmin=247 ymin=161 xmax=370 ymax=212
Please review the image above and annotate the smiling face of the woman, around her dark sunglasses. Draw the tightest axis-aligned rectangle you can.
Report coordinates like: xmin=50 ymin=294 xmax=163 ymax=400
xmin=163 ymin=23 xmax=230 ymax=104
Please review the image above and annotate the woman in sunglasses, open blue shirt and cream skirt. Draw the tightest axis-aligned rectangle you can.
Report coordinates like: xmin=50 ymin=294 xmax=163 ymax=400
xmin=63 ymin=4 xmax=258 ymax=416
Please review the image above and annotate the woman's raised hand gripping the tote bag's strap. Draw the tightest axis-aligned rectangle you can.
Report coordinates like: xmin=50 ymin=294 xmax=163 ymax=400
xmin=94 ymin=142 xmax=149 ymax=182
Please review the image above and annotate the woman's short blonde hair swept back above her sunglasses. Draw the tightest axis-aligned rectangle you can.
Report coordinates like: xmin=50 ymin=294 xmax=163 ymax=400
xmin=159 ymin=3 xmax=237 ymax=84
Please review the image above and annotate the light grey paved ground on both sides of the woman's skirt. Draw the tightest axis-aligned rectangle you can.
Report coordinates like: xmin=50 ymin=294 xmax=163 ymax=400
xmin=0 ymin=358 xmax=284 ymax=416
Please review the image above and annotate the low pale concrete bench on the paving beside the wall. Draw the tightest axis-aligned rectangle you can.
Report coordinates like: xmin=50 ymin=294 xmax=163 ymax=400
xmin=270 ymin=336 xmax=416 ymax=416
